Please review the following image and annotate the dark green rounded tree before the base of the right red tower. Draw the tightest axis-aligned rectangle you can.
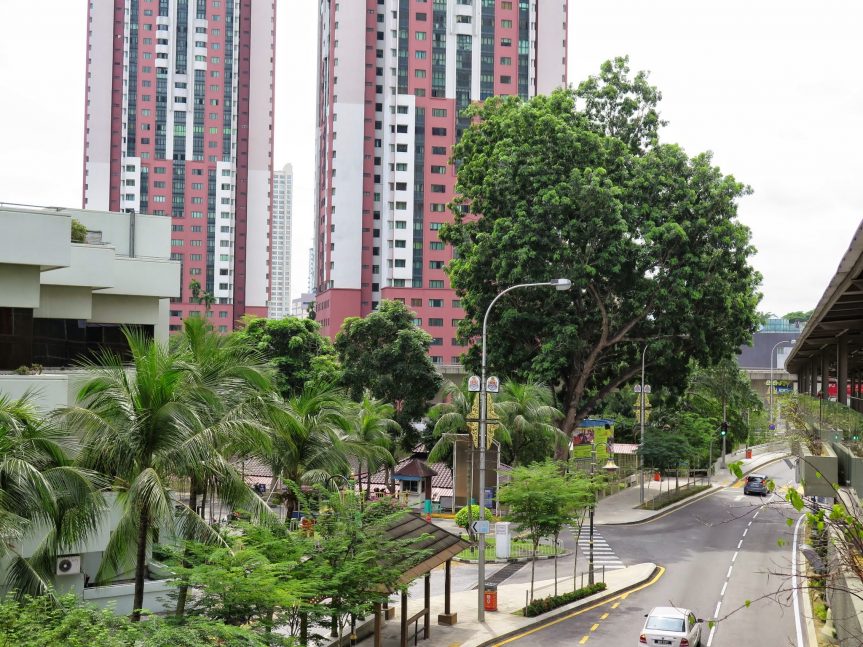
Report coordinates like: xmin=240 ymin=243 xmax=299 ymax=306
xmin=336 ymin=301 xmax=442 ymax=449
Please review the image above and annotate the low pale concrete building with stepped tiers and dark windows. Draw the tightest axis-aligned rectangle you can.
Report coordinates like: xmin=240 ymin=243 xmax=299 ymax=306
xmin=0 ymin=203 xmax=180 ymax=411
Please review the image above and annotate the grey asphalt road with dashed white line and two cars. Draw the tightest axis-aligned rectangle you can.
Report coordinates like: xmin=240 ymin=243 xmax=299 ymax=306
xmin=501 ymin=461 xmax=807 ymax=647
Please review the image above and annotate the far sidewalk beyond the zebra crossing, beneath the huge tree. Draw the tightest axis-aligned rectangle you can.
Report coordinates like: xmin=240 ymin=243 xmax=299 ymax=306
xmin=594 ymin=451 xmax=788 ymax=526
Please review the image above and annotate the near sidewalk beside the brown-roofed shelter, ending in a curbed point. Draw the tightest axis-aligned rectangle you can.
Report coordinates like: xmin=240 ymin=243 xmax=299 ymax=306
xmin=352 ymin=563 xmax=657 ymax=647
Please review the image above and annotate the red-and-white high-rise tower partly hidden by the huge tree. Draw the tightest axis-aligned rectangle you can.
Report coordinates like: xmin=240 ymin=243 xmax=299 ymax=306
xmin=314 ymin=0 xmax=567 ymax=364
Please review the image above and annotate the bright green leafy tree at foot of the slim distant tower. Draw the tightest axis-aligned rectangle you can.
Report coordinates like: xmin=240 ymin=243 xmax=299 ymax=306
xmin=234 ymin=317 xmax=341 ymax=398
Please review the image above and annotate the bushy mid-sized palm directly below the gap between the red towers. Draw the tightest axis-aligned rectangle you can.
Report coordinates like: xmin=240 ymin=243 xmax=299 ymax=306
xmin=258 ymin=382 xmax=351 ymax=519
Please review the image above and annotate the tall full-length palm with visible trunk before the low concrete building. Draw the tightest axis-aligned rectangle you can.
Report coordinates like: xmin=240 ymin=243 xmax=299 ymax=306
xmin=63 ymin=330 xmax=269 ymax=621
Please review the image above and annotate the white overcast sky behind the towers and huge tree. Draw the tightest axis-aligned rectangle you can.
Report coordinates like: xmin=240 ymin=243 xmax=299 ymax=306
xmin=0 ymin=0 xmax=863 ymax=315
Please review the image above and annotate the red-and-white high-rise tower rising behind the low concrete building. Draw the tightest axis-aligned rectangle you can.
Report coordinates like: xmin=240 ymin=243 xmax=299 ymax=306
xmin=84 ymin=0 xmax=276 ymax=332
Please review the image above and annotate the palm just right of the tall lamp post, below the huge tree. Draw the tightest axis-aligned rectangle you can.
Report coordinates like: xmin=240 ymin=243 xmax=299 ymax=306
xmin=495 ymin=380 xmax=569 ymax=466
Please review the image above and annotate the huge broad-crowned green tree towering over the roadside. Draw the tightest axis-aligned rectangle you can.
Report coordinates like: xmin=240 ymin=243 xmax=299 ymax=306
xmin=441 ymin=59 xmax=760 ymax=433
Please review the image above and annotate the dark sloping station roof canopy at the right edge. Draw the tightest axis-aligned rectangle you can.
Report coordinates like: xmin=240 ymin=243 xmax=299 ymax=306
xmin=785 ymin=221 xmax=863 ymax=374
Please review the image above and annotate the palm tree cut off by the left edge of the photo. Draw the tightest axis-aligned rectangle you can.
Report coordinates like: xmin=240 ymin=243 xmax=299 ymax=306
xmin=0 ymin=393 xmax=104 ymax=595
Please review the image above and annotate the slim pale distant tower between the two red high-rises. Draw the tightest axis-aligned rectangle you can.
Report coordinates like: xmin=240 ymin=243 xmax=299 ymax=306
xmin=268 ymin=164 xmax=294 ymax=319
